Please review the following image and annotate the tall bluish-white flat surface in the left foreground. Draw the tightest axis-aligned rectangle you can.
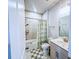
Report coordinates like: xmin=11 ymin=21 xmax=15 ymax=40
xmin=9 ymin=0 xmax=25 ymax=59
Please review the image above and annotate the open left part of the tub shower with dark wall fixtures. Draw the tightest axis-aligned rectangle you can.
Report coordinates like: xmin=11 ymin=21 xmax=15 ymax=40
xmin=25 ymin=18 xmax=38 ymax=50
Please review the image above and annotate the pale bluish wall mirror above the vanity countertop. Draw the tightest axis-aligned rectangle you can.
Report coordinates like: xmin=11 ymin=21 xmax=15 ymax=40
xmin=59 ymin=16 xmax=70 ymax=37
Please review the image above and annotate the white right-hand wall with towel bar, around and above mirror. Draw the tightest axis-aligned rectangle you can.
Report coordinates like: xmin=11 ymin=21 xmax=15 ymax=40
xmin=43 ymin=0 xmax=70 ymax=38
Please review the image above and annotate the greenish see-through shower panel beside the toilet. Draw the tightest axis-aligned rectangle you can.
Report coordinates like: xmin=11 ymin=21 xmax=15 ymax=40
xmin=38 ymin=20 xmax=48 ymax=48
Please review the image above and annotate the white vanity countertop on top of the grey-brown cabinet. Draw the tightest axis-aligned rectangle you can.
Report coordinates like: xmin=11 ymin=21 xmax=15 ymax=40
xmin=49 ymin=37 xmax=68 ymax=51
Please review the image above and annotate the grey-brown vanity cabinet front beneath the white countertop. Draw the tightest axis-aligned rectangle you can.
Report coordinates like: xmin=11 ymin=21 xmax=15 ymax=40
xmin=50 ymin=42 xmax=68 ymax=59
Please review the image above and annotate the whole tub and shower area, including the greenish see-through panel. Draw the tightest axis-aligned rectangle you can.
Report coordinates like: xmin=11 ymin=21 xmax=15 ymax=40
xmin=25 ymin=18 xmax=47 ymax=50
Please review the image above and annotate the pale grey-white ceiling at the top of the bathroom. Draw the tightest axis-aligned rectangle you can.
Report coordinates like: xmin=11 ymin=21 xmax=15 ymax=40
xmin=25 ymin=0 xmax=59 ymax=13
